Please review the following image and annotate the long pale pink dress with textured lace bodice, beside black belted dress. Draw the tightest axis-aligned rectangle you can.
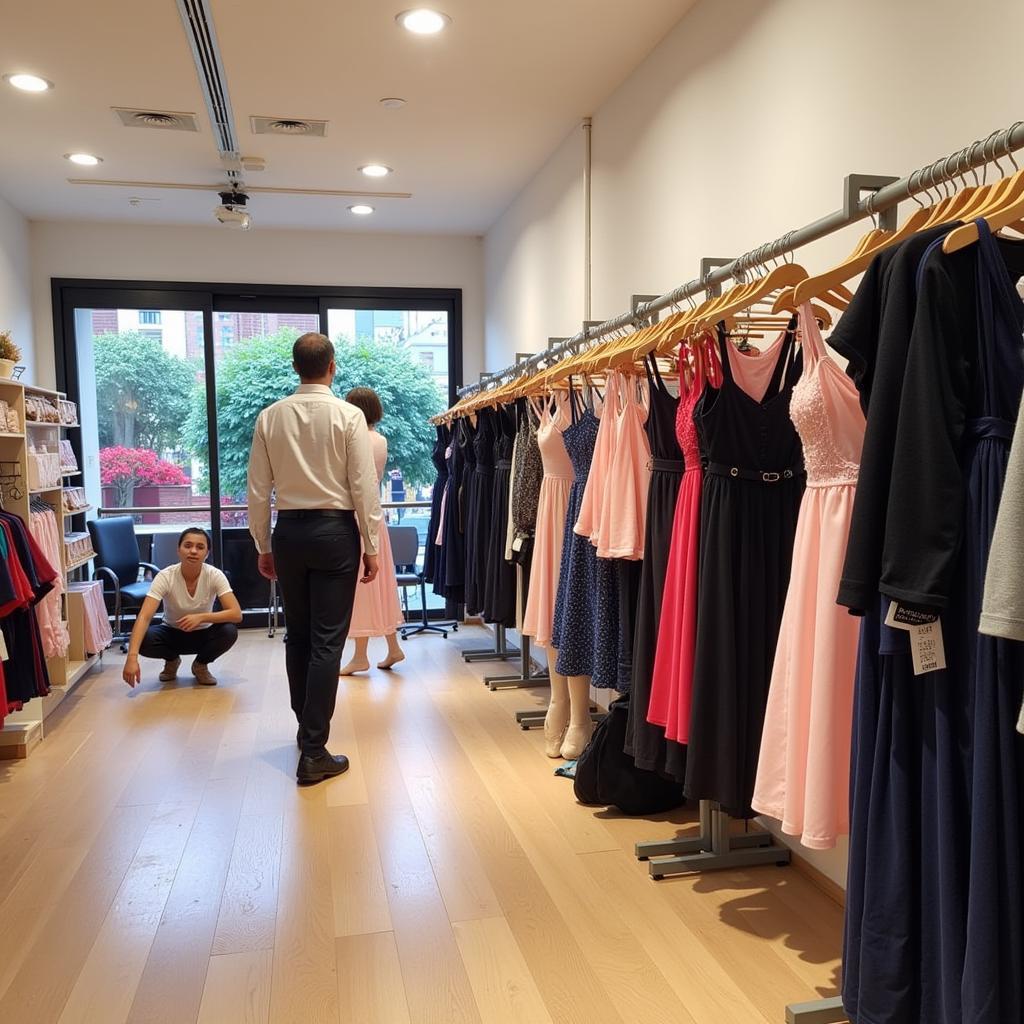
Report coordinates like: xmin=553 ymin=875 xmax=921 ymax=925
xmin=752 ymin=305 xmax=864 ymax=850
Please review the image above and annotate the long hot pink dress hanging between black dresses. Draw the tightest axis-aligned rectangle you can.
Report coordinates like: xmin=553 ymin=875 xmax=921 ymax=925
xmin=647 ymin=339 xmax=722 ymax=743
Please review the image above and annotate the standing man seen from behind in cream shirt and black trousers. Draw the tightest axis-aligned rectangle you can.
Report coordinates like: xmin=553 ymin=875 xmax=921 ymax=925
xmin=249 ymin=334 xmax=382 ymax=785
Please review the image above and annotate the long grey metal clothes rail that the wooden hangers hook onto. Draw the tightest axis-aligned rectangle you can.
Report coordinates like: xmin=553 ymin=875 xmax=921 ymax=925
xmin=458 ymin=121 xmax=1024 ymax=397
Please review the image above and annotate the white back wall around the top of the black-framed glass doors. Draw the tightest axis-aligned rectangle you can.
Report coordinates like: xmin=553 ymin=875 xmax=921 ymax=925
xmin=28 ymin=221 xmax=483 ymax=385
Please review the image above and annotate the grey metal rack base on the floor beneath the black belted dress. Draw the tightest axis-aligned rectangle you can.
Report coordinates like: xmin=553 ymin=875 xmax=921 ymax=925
xmin=636 ymin=800 xmax=786 ymax=880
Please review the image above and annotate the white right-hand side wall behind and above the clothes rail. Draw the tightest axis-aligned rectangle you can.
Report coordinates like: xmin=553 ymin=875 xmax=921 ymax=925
xmin=484 ymin=0 xmax=1024 ymax=882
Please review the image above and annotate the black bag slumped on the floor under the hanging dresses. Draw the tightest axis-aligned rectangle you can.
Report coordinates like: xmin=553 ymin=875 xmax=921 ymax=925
xmin=573 ymin=694 xmax=684 ymax=815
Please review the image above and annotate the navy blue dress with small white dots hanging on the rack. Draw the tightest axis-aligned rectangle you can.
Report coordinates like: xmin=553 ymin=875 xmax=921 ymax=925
xmin=551 ymin=381 xmax=600 ymax=677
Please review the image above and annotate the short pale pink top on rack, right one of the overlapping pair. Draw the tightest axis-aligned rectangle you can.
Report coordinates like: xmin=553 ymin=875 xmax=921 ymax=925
xmin=591 ymin=377 xmax=650 ymax=561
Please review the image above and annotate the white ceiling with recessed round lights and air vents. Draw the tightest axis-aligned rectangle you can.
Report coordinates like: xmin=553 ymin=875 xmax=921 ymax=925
xmin=0 ymin=0 xmax=693 ymax=233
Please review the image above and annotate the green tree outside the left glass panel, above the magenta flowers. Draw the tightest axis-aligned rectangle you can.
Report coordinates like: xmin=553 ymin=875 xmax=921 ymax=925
xmin=93 ymin=331 xmax=197 ymax=454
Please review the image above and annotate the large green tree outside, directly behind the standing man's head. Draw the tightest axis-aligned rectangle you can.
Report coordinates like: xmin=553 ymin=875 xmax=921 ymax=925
xmin=184 ymin=328 xmax=445 ymax=500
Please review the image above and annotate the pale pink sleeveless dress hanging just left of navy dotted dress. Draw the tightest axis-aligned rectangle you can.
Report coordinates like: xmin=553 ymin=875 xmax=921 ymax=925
xmin=522 ymin=394 xmax=573 ymax=647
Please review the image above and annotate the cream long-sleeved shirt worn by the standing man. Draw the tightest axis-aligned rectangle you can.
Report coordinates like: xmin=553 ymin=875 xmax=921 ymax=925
xmin=249 ymin=384 xmax=382 ymax=555
